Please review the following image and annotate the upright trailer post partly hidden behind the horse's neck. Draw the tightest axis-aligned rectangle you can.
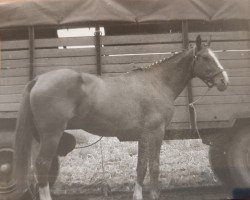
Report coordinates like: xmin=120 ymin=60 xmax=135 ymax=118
xmin=182 ymin=20 xmax=195 ymax=130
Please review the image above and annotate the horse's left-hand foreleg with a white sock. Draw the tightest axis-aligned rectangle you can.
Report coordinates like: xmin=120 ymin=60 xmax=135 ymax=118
xmin=133 ymin=135 xmax=148 ymax=200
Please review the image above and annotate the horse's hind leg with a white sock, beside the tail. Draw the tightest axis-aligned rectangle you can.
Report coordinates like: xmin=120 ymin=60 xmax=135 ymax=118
xmin=36 ymin=132 xmax=62 ymax=200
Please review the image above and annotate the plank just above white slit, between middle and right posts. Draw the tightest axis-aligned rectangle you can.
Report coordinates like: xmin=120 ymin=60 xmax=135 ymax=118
xmin=101 ymin=43 xmax=182 ymax=55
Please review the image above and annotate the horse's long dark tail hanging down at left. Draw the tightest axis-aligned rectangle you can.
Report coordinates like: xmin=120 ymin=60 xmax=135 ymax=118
xmin=13 ymin=80 xmax=36 ymax=192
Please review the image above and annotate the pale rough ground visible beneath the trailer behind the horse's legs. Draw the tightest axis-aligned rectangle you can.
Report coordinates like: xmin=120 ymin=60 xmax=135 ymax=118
xmin=53 ymin=131 xmax=220 ymax=194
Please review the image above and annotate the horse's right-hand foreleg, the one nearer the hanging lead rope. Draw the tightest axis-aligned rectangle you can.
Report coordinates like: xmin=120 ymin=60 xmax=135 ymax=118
xmin=149 ymin=127 xmax=165 ymax=200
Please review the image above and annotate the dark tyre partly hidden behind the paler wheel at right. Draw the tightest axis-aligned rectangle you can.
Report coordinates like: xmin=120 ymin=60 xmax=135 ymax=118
xmin=209 ymin=137 xmax=234 ymax=187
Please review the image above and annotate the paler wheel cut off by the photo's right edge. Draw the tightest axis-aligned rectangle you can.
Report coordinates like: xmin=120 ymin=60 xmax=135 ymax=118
xmin=228 ymin=126 xmax=250 ymax=188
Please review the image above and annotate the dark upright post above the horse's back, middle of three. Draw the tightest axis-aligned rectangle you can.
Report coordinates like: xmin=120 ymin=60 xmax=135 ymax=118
xmin=95 ymin=26 xmax=102 ymax=76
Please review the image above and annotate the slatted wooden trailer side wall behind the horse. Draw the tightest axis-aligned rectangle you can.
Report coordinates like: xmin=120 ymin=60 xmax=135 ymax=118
xmin=0 ymin=27 xmax=250 ymax=133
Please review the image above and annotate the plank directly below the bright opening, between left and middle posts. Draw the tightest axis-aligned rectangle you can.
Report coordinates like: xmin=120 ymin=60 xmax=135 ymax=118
xmin=35 ymin=36 xmax=95 ymax=48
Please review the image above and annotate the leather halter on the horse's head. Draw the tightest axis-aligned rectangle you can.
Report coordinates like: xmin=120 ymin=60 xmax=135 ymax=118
xmin=192 ymin=46 xmax=225 ymax=88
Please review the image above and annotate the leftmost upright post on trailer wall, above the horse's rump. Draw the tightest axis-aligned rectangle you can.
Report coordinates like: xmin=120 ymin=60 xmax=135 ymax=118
xmin=28 ymin=26 xmax=35 ymax=80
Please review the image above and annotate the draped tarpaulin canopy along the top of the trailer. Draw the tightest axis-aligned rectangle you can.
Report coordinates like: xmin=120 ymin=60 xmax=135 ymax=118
xmin=0 ymin=0 xmax=250 ymax=28
